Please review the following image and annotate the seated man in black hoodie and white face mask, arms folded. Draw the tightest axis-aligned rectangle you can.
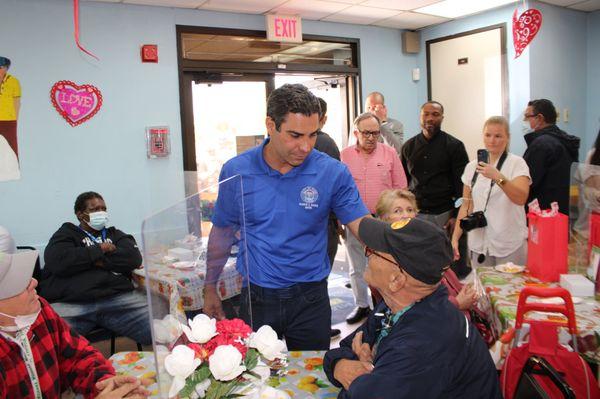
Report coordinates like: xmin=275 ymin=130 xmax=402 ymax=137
xmin=40 ymin=191 xmax=152 ymax=345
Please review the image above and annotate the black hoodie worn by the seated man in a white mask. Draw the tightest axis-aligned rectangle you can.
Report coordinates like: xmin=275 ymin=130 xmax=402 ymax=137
xmin=40 ymin=223 xmax=142 ymax=302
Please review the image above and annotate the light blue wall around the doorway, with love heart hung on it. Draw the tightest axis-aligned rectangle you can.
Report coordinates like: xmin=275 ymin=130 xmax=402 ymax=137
xmin=0 ymin=0 xmax=418 ymax=246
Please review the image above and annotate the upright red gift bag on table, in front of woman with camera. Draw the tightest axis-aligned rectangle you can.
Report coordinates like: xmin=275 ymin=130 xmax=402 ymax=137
xmin=527 ymin=212 xmax=569 ymax=281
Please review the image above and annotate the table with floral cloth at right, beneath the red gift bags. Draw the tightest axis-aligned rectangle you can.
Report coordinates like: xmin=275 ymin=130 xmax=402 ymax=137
xmin=477 ymin=267 xmax=600 ymax=364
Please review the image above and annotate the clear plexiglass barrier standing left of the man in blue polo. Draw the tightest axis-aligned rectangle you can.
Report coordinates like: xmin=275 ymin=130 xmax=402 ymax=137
xmin=141 ymin=176 xmax=252 ymax=398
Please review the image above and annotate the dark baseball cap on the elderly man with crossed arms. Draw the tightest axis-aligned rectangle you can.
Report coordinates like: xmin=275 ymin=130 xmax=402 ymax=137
xmin=358 ymin=218 xmax=454 ymax=284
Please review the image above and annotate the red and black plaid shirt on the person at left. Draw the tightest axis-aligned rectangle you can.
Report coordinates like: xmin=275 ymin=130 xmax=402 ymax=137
xmin=0 ymin=298 xmax=115 ymax=399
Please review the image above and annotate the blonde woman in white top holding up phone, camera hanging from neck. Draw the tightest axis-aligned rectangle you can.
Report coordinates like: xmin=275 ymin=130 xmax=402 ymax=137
xmin=452 ymin=116 xmax=531 ymax=267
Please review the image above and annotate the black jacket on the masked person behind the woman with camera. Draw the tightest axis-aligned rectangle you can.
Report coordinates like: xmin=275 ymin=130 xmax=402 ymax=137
xmin=523 ymin=125 xmax=580 ymax=215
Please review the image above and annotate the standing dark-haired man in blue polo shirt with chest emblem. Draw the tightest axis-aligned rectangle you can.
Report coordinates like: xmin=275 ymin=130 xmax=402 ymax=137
xmin=204 ymin=84 xmax=369 ymax=350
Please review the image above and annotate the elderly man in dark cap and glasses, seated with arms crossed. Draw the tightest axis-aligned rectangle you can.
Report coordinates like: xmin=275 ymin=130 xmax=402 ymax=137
xmin=324 ymin=218 xmax=501 ymax=399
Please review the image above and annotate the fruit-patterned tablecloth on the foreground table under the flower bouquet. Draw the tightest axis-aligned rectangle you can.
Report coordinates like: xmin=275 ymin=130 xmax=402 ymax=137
xmin=110 ymin=351 xmax=339 ymax=399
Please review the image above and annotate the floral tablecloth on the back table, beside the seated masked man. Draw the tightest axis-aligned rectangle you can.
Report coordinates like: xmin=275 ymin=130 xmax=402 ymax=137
xmin=133 ymin=258 xmax=242 ymax=314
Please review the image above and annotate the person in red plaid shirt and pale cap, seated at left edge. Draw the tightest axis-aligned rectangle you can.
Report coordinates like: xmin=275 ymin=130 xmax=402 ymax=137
xmin=0 ymin=233 xmax=150 ymax=399
